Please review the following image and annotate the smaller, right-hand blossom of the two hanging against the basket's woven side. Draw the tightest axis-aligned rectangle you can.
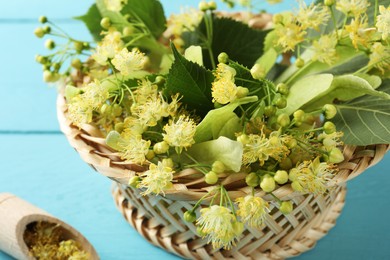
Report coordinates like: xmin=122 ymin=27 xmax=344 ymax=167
xmin=236 ymin=195 xmax=269 ymax=228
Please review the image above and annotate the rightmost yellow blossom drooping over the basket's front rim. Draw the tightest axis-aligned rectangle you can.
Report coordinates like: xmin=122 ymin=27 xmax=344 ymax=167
xmin=290 ymin=157 xmax=334 ymax=194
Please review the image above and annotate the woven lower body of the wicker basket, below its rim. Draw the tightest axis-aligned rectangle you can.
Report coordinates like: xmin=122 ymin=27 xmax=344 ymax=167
xmin=113 ymin=184 xmax=346 ymax=259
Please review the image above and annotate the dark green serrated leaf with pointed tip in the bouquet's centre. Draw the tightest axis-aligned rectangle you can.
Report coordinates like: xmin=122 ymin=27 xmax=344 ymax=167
xmin=164 ymin=44 xmax=214 ymax=117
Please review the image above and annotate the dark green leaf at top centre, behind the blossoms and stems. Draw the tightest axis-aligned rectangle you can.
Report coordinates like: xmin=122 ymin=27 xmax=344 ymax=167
xmin=183 ymin=16 xmax=268 ymax=68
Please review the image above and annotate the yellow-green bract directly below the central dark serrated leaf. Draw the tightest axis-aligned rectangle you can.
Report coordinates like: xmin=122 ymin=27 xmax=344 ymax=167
xmin=194 ymin=96 xmax=258 ymax=143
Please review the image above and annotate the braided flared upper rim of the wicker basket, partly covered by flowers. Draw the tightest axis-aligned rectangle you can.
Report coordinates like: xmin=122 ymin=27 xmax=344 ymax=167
xmin=57 ymin=91 xmax=390 ymax=201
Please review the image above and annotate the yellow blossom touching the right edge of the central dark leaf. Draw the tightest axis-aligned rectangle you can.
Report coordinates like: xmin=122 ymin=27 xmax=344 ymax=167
xmin=211 ymin=78 xmax=237 ymax=105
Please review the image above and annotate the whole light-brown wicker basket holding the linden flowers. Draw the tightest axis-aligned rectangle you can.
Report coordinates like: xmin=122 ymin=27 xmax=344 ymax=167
xmin=57 ymin=91 xmax=389 ymax=259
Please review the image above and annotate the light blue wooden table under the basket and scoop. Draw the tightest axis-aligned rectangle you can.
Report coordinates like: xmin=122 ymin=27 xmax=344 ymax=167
xmin=0 ymin=0 xmax=390 ymax=260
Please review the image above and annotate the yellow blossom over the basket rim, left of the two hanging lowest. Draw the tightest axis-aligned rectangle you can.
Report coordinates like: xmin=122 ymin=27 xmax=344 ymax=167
xmin=138 ymin=162 xmax=174 ymax=195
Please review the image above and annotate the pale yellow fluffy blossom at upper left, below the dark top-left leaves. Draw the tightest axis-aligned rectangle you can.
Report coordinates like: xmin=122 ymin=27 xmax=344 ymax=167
xmin=112 ymin=48 xmax=147 ymax=76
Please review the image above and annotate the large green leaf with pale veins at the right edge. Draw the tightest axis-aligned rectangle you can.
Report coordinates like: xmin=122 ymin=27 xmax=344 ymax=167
xmin=332 ymin=79 xmax=390 ymax=146
